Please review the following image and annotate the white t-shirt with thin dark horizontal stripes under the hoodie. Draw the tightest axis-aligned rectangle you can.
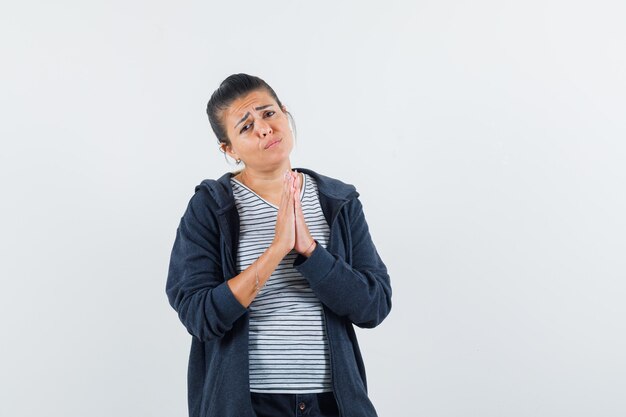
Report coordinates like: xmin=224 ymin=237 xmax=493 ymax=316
xmin=231 ymin=173 xmax=332 ymax=393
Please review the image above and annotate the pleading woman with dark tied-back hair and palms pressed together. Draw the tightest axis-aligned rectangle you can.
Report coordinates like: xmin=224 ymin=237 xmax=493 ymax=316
xmin=166 ymin=74 xmax=391 ymax=417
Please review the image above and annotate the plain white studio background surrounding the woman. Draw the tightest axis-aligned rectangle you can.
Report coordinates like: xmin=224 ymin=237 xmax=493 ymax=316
xmin=0 ymin=0 xmax=626 ymax=417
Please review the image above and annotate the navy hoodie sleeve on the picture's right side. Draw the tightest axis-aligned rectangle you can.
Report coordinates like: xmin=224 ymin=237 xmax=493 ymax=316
xmin=294 ymin=197 xmax=391 ymax=328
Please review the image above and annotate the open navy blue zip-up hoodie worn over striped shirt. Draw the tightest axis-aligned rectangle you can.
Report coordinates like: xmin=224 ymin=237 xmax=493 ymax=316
xmin=166 ymin=168 xmax=391 ymax=417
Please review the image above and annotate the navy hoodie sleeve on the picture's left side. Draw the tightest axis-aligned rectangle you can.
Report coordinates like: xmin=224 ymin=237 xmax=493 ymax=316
xmin=165 ymin=188 xmax=247 ymax=341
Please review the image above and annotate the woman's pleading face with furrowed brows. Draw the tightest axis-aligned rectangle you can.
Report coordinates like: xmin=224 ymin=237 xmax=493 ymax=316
xmin=222 ymin=89 xmax=293 ymax=170
